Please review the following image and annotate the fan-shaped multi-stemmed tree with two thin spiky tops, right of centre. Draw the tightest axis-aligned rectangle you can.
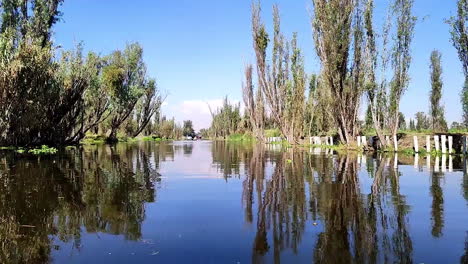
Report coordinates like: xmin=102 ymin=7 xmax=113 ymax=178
xmin=252 ymin=4 xmax=307 ymax=142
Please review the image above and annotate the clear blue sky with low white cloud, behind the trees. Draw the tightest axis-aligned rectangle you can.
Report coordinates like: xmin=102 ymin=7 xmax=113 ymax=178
xmin=55 ymin=0 xmax=464 ymax=129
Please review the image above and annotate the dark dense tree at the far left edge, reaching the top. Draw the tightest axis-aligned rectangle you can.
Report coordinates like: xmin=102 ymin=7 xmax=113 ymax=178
xmin=0 ymin=0 xmax=93 ymax=146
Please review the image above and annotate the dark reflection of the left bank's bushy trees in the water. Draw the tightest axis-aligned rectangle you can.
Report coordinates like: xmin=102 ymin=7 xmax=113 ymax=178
xmin=0 ymin=143 xmax=165 ymax=263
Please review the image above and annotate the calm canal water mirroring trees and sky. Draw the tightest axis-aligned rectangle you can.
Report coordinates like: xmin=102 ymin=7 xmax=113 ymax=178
xmin=0 ymin=141 xmax=468 ymax=263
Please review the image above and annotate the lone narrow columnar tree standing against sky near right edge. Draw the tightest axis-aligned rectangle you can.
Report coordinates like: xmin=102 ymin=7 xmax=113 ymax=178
xmin=429 ymin=50 xmax=447 ymax=131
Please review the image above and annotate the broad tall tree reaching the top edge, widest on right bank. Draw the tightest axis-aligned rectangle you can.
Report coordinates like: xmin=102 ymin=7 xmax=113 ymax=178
xmin=312 ymin=0 xmax=363 ymax=145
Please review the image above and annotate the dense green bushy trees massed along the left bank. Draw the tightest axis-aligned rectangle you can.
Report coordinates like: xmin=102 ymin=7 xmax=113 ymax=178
xmin=0 ymin=0 xmax=164 ymax=146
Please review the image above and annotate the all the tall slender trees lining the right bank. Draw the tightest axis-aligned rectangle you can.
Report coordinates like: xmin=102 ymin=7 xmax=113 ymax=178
xmin=238 ymin=0 xmax=468 ymax=145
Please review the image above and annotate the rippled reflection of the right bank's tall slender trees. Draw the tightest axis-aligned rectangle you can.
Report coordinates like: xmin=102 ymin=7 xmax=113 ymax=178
xmin=243 ymin=147 xmax=412 ymax=263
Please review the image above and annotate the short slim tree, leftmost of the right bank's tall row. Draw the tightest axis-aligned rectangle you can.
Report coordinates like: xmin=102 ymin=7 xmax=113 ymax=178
xmin=242 ymin=64 xmax=265 ymax=141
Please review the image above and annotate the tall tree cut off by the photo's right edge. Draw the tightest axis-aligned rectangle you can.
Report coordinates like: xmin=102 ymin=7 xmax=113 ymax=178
xmin=449 ymin=0 xmax=468 ymax=127
